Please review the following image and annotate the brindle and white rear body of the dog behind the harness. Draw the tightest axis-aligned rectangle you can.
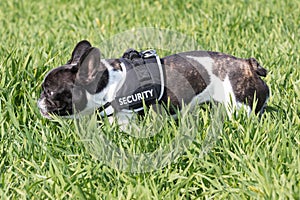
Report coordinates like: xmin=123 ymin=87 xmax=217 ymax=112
xmin=162 ymin=51 xmax=269 ymax=113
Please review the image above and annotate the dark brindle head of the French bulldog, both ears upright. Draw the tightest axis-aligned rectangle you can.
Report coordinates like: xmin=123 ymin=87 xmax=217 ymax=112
xmin=38 ymin=40 xmax=108 ymax=118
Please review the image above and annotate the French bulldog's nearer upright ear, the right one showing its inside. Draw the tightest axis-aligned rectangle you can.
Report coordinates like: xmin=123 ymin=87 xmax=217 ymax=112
xmin=76 ymin=47 xmax=106 ymax=85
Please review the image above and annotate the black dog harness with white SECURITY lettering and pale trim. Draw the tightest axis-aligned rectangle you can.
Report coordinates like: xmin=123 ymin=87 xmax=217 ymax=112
xmin=100 ymin=49 xmax=165 ymax=116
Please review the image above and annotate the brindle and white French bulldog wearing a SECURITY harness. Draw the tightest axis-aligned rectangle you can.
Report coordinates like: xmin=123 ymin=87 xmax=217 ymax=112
xmin=38 ymin=40 xmax=269 ymax=122
